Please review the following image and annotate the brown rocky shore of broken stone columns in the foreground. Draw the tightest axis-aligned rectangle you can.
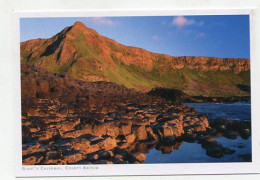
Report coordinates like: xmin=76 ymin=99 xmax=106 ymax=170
xmin=21 ymin=65 xmax=251 ymax=165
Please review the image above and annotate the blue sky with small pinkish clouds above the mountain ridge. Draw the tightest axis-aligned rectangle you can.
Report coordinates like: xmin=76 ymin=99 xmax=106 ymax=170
xmin=20 ymin=15 xmax=250 ymax=58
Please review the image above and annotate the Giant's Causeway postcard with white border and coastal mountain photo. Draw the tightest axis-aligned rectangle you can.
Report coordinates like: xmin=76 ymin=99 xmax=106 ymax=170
xmin=14 ymin=11 xmax=259 ymax=177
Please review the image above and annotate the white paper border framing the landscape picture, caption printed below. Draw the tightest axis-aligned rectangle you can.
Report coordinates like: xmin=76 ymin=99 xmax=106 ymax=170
xmin=13 ymin=8 xmax=260 ymax=177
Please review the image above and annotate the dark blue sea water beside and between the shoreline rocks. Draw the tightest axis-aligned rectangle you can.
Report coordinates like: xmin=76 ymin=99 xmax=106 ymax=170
xmin=144 ymin=102 xmax=252 ymax=164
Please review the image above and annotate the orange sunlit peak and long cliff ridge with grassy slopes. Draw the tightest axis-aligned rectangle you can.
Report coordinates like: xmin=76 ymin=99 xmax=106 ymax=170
xmin=21 ymin=22 xmax=250 ymax=95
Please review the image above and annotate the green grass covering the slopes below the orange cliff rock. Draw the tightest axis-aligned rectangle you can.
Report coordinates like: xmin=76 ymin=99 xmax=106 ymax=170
xmin=21 ymin=33 xmax=250 ymax=96
